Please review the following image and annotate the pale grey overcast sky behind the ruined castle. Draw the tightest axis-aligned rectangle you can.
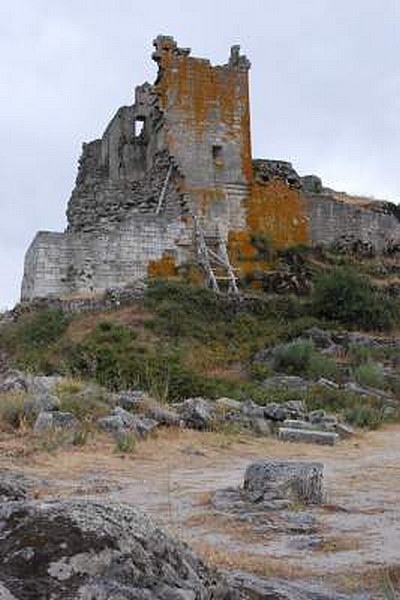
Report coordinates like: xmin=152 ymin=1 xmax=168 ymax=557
xmin=0 ymin=0 xmax=400 ymax=310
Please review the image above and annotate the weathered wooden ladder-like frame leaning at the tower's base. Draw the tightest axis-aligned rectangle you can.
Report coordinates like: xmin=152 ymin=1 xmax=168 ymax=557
xmin=193 ymin=216 xmax=239 ymax=294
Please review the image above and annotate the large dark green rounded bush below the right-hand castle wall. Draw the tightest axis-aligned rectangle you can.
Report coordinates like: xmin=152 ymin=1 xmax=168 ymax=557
xmin=313 ymin=268 xmax=394 ymax=329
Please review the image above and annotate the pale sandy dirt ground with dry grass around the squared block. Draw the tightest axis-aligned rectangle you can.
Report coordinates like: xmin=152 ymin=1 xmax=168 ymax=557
xmin=0 ymin=427 xmax=400 ymax=600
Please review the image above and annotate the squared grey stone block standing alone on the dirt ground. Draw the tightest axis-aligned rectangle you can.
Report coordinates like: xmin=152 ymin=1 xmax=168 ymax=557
xmin=243 ymin=460 xmax=323 ymax=504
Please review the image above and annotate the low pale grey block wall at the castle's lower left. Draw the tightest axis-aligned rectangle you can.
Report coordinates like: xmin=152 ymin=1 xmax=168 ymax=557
xmin=21 ymin=215 xmax=191 ymax=300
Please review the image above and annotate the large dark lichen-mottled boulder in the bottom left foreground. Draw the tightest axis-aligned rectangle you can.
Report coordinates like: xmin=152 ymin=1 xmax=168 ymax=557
xmin=0 ymin=501 xmax=238 ymax=600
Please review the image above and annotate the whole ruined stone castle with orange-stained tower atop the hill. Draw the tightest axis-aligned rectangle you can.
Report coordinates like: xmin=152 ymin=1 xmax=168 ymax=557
xmin=22 ymin=36 xmax=400 ymax=300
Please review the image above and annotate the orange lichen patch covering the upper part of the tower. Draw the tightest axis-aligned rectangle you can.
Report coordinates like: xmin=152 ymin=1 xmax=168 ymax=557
xmin=154 ymin=52 xmax=252 ymax=188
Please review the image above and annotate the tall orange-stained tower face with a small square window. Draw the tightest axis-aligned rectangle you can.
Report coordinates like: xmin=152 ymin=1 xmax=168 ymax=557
xmin=153 ymin=36 xmax=252 ymax=237
